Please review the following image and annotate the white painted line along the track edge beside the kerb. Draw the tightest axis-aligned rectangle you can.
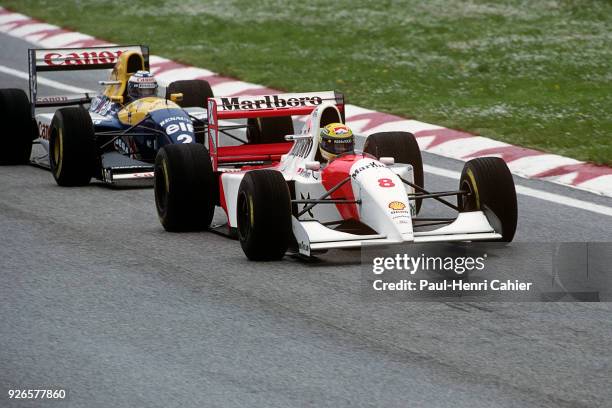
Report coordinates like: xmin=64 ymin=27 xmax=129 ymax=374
xmin=0 ymin=65 xmax=612 ymax=217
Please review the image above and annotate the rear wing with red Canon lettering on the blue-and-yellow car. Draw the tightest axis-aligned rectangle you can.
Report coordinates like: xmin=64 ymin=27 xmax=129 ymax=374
xmin=28 ymin=45 xmax=149 ymax=116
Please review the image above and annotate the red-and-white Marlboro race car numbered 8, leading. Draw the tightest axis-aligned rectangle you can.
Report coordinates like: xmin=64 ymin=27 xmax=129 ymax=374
xmin=155 ymin=92 xmax=517 ymax=260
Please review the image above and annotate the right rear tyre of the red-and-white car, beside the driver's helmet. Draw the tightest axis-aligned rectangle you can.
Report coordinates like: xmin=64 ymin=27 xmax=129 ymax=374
xmin=363 ymin=132 xmax=425 ymax=214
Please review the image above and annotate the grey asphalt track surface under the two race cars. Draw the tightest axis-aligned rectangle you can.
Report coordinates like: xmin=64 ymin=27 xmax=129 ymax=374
xmin=0 ymin=35 xmax=612 ymax=407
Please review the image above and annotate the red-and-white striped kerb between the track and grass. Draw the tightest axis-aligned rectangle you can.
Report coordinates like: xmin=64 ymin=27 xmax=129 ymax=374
xmin=0 ymin=7 xmax=612 ymax=197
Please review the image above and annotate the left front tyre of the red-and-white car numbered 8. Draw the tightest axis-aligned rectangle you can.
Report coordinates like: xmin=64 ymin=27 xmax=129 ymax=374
xmin=236 ymin=170 xmax=292 ymax=261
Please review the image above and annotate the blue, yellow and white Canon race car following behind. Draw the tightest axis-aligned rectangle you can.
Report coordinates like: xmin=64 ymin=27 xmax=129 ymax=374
xmin=0 ymin=45 xmax=218 ymax=186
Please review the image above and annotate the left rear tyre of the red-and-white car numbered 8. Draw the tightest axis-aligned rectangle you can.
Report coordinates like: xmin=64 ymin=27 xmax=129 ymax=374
xmin=154 ymin=143 xmax=217 ymax=232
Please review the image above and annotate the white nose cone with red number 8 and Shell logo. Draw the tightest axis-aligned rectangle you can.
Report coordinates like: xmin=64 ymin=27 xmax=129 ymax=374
xmin=350 ymin=158 xmax=413 ymax=241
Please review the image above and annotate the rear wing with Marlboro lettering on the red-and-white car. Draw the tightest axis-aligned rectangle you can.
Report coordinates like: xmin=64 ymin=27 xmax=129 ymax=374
xmin=208 ymin=91 xmax=345 ymax=170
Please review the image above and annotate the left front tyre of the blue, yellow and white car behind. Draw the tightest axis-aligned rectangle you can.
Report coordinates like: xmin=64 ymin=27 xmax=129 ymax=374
xmin=49 ymin=107 xmax=97 ymax=187
